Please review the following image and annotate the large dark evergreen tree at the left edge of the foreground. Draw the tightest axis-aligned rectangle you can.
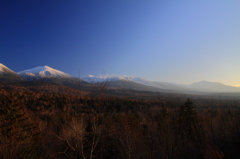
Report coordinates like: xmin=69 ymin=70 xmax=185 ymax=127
xmin=0 ymin=92 xmax=40 ymax=158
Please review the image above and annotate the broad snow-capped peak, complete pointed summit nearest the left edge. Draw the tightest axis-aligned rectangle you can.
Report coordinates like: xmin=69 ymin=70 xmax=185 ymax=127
xmin=18 ymin=66 xmax=72 ymax=80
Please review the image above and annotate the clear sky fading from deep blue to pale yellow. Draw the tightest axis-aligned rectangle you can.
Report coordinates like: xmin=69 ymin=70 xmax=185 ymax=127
xmin=0 ymin=0 xmax=240 ymax=85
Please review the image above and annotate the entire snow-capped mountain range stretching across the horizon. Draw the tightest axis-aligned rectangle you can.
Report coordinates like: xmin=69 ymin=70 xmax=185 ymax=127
xmin=0 ymin=64 xmax=240 ymax=94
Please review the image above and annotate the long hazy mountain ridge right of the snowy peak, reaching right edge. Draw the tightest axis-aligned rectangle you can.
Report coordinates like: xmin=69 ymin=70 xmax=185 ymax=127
xmin=83 ymin=75 xmax=240 ymax=93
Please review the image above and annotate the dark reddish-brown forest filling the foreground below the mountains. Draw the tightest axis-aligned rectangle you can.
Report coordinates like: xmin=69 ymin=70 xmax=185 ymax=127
xmin=0 ymin=89 xmax=240 ymax=159
